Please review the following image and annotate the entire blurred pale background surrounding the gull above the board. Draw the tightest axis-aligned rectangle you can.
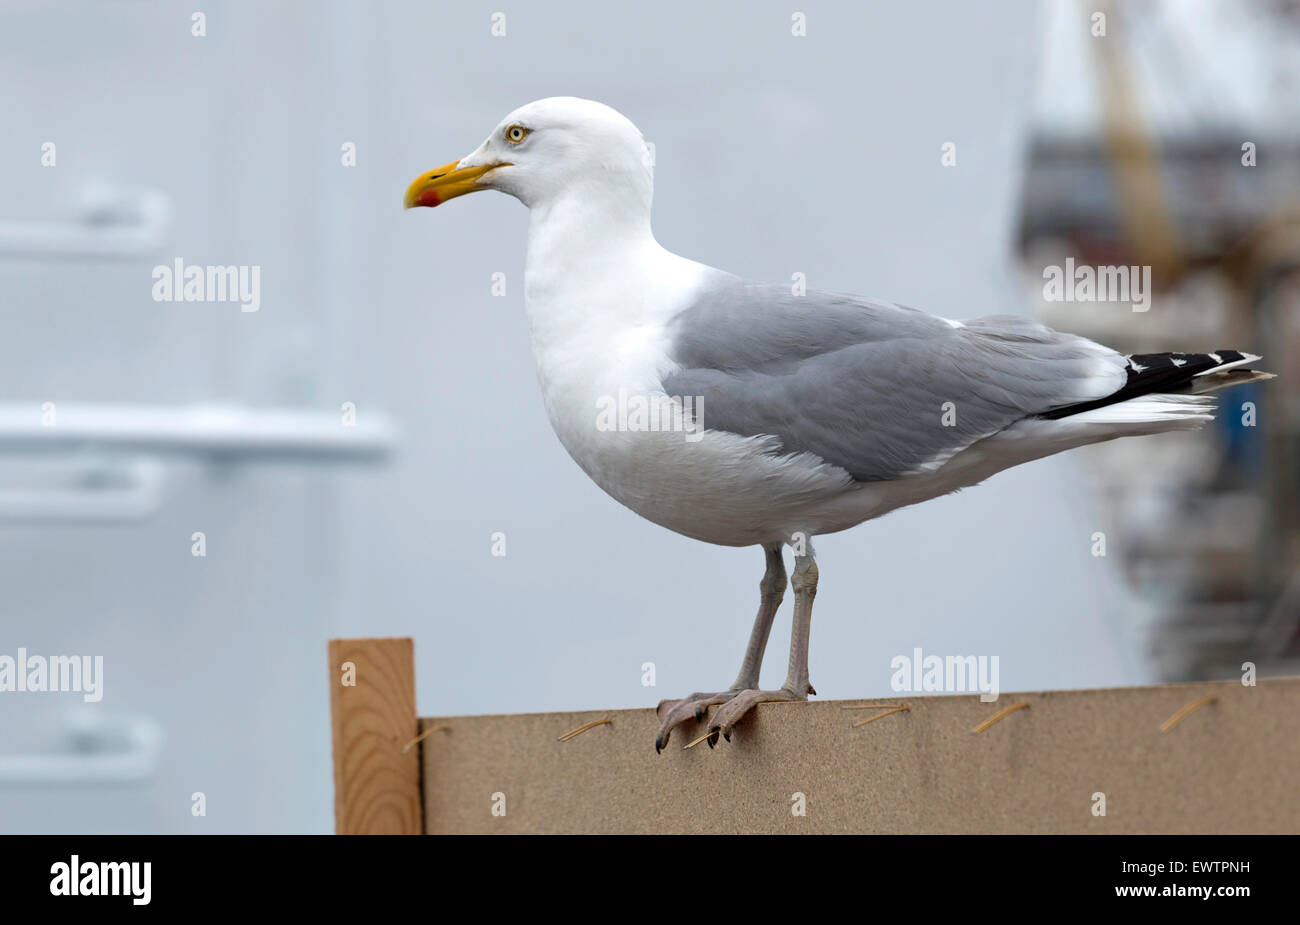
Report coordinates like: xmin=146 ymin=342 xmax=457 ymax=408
xmin=0 ymin=0 xmax=1300 ymax=833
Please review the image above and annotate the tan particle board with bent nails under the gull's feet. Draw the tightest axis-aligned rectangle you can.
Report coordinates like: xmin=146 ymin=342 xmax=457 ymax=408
xmin=420 ymin=679 xmax=1300 ymax=834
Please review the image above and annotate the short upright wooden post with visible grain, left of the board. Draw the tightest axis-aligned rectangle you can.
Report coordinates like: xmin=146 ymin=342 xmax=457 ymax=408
xmin=329 ymin=638 xmax=424 ymax=835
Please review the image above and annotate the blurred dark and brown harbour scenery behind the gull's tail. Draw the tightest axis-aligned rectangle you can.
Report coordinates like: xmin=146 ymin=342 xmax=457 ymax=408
xmin=1017 ymin=0 xmax=1300 ymax=681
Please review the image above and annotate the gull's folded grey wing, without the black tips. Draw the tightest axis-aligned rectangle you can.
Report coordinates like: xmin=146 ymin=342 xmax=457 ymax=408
xmin=663 ymin=278 xmax=1127 ymax=481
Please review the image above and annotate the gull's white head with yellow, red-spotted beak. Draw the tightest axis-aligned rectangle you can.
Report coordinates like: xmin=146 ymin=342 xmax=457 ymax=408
xmin=404 ymin=96 xmax=654 ymax=214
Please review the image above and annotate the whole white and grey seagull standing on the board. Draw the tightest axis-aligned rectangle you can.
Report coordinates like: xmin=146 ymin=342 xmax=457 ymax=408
xmin=404 ymin=96 xmax=1271 ymax=751
